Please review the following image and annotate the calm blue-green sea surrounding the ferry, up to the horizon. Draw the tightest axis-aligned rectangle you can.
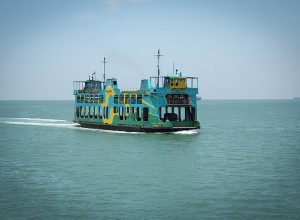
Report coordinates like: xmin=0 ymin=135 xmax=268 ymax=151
xmin=0 ymin=100 xmax=300 ymax=219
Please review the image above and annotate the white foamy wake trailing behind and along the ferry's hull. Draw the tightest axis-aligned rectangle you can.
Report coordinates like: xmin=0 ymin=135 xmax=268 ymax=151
xmin=0 ymin=118 xmax=199 ymax=135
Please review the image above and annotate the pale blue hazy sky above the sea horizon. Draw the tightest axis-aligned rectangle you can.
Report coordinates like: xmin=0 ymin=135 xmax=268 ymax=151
xmin=0 ymin=0 xmax=300 ymax=99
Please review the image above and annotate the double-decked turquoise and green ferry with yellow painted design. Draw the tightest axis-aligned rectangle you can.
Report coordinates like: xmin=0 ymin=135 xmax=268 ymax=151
xmin=73 ymin=50 xmax=200 ymax=132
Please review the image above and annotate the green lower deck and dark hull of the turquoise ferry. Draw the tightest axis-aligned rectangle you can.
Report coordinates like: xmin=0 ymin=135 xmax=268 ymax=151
xmin=74 ymin=106 xmax=200 ymax=132
